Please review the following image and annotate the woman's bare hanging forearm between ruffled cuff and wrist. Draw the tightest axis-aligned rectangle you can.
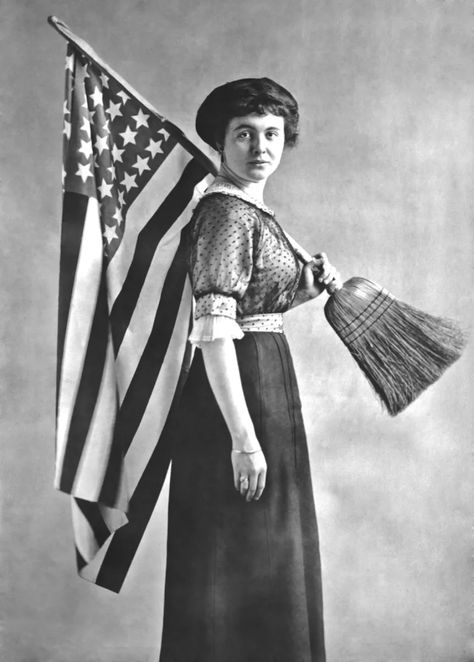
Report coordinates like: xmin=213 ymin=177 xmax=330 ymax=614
xmin=201 ymin=338 xmax=259 ymax=450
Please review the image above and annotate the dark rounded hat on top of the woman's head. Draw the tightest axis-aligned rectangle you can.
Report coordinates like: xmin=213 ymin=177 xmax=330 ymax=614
xmin=196 ymin=78 xmax=298 ymax=149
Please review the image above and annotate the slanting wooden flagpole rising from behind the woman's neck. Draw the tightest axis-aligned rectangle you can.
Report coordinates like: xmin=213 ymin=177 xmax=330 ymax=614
xmin=48 ymin=16 xmax=217 ymax=175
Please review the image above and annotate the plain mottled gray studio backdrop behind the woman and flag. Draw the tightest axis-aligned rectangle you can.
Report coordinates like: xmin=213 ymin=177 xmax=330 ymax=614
xmin=0 ymin=0 xmax=474 ymax=662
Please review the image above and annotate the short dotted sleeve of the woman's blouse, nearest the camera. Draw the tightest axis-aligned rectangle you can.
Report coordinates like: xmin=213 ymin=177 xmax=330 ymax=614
xmin=190 ymin=195 xmax=258 ymax=321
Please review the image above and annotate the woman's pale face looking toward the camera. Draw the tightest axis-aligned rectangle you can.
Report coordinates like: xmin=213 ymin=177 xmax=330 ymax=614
xmin=224 ymin=113 xmax=285 ymax=183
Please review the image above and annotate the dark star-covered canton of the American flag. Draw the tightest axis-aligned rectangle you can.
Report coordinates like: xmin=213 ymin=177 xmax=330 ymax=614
xmin=63 ymin=47 xmax=176 ymax=258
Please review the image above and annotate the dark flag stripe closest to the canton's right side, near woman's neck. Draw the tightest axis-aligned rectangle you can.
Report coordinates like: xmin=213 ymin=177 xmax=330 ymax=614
xmin=110 ymin=159 xmax=207 ymax=354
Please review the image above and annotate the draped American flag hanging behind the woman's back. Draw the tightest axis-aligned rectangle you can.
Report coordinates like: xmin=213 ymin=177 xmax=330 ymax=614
xmin=55 ymin=33 xmax=213 ymax=592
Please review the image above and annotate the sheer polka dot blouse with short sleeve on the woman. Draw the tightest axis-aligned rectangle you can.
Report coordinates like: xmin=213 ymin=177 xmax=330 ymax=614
xmin=189 ymin=187 xmax=301 ymax=319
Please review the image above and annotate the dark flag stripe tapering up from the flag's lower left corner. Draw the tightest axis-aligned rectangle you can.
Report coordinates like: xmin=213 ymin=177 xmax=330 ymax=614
xmin=60 ymin=269 xmax=109 ymax=492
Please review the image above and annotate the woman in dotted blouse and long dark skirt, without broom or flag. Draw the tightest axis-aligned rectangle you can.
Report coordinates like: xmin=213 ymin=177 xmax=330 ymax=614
xmin=160 ymin=78 xmax=338 ymax=662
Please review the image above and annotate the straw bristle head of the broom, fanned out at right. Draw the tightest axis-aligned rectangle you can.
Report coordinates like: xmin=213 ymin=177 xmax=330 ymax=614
xmin=324 ymin=278 xmax=467 ymax=416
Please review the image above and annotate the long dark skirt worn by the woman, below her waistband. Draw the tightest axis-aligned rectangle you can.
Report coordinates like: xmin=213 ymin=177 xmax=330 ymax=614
xmin=160 ymin=333 xmax=325 ymax=662
